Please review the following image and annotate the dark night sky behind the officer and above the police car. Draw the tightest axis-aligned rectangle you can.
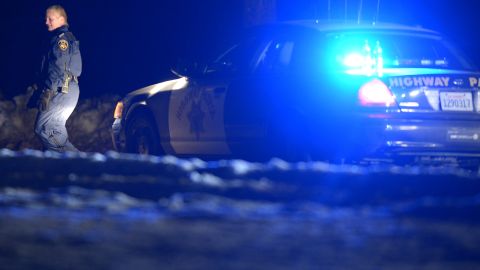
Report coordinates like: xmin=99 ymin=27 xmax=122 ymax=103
xmin=0 ymin=0 xmax=480 ymax=97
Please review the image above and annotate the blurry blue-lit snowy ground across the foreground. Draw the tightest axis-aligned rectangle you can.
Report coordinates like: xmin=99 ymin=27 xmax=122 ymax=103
xmin=0 ymin=149 xmax=480 ymax=269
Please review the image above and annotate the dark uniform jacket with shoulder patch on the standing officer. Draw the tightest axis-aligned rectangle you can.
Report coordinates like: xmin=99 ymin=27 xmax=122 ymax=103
xmin=38 ymin=25 xmax=82 ymax=91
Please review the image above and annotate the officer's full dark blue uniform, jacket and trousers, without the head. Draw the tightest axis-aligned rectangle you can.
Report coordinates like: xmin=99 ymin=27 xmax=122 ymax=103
xmin=35 ymin=25 xmax=82 ymax=152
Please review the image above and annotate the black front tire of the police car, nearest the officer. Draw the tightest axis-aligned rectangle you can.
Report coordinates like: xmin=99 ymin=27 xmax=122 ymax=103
xmin=126 ymin=112 xmax=163 ymax=155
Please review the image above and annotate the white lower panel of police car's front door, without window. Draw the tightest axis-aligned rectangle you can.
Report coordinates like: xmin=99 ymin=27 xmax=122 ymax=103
xmin=168 ymin=78 xmax=229 ymax=155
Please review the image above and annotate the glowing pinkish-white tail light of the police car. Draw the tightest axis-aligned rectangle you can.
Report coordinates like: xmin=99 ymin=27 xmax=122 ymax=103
xmin=358 ymin=79 xmax=395 ymax=107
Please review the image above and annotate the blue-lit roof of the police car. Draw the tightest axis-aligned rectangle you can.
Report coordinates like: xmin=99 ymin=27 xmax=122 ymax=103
xmin=270 ymin=20 xmax=439 ymax=35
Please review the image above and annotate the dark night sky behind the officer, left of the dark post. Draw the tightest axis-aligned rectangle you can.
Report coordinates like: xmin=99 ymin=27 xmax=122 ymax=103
xmin=0 ymin=0 xmax=246 ymax=96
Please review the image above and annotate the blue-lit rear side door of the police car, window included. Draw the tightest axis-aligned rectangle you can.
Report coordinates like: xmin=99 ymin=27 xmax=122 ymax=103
xmin=225 ymin=35 xmax=302 ymax=156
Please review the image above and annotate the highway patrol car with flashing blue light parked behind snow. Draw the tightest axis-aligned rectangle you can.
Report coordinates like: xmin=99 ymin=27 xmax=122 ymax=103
xmin=113 ymin=21 xmax=480 ymax=162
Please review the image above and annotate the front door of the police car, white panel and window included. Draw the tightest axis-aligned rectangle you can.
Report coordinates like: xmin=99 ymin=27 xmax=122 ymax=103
xmin=169 ymin=36 xmax=270 ymax=155
